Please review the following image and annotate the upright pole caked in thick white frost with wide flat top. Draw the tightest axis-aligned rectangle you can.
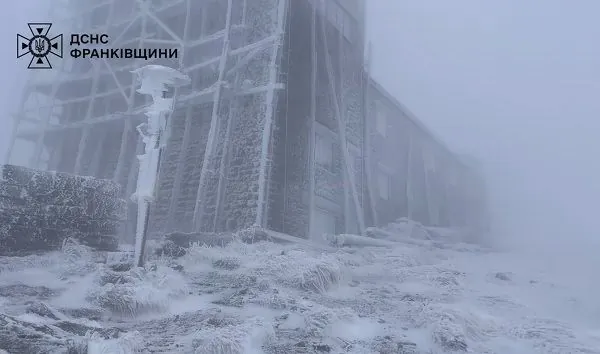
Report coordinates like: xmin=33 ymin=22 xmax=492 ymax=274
xmin=131 ymin=65 xmax=190 ymax=267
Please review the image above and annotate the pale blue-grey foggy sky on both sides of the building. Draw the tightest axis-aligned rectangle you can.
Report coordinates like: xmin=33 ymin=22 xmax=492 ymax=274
xmin=0 ymin=0 xmax=600 ymax=258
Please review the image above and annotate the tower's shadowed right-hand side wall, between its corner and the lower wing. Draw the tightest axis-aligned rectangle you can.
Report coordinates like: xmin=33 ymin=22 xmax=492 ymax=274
xmin=268 ymin=1 xmax=364 ymax=238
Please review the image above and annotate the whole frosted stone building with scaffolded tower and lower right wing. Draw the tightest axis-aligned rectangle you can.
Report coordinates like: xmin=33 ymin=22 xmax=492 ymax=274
xmin=5 ymin=0 xmax=488 ymax=242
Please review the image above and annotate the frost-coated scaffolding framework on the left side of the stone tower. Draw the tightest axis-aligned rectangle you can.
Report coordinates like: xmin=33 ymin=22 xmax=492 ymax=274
xmin=8 ymin=0 xmax=287 ymax=235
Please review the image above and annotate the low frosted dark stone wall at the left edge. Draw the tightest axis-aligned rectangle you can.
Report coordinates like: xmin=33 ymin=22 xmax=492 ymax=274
xmin=0 ymin=165 xmax=126 ymax=255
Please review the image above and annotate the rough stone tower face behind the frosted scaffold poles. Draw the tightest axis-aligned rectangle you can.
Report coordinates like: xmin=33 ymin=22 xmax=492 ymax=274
xmin=150 ymin=0 xmax=280 ymax=235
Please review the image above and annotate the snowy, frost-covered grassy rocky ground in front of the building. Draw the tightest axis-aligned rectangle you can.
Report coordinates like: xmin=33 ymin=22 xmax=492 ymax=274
xmin=0 ymin=228 xmax=600 ymax=354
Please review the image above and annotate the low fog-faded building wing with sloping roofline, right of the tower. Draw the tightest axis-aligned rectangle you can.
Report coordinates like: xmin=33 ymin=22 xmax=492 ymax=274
xmin=366 ymin=80 xmax=487 ymax=227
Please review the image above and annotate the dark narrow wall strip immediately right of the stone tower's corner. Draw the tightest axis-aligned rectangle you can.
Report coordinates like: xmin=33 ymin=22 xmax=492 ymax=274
xmin=267 ymin=1 xmax=312 ymax=237
